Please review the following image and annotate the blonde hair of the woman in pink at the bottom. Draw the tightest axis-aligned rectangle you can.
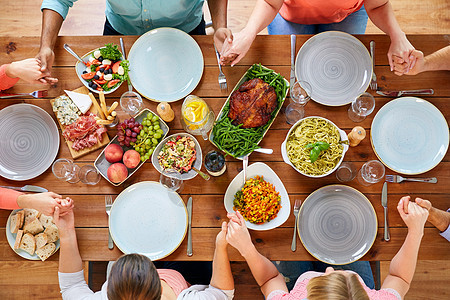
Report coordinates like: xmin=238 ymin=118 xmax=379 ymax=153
xmin=306 ymin=273 xmax=369 ymax=300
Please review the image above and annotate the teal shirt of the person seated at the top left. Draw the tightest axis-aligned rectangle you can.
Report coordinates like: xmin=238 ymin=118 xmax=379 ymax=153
xmin=41 ymin=0 xmax=204 ymax=35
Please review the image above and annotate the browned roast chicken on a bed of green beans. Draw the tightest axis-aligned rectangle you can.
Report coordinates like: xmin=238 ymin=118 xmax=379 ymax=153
xmin=228 ymin=78 xmax=277 ymax=128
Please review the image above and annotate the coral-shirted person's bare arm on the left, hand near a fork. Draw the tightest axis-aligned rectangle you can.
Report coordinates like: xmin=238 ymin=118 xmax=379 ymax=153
xmin=218 ymin=0 xmax=283 ymax=66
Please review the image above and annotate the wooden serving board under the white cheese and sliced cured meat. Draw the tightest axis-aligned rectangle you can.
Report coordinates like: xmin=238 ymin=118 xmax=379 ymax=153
xmin=50 ymin=86 xmax=110 ymax=159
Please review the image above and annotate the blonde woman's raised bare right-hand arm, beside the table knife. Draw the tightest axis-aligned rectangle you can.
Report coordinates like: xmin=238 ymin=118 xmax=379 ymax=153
xmin=381 ymin=196 xmax=428 ymax=299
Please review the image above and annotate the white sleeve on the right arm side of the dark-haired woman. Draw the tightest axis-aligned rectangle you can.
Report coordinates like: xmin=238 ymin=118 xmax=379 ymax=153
xmin=177 ymin=284 xmax=234 ymax=300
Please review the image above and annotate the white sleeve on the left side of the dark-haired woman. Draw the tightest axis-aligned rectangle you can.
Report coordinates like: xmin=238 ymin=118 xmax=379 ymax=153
xmin=58 ymin=270 xmax=102 ymax=300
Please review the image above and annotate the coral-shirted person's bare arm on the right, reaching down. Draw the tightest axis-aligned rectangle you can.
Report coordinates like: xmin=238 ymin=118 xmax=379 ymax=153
xmin=364 ymin=0 xmax=414 ymax=71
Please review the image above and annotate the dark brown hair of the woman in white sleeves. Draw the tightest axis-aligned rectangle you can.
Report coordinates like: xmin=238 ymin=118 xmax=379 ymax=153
xmin=107 ymin=254 xmax=161 ymax=300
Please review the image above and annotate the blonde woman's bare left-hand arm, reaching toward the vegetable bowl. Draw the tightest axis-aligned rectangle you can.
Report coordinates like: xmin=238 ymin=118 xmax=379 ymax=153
xmin=227 ymin=212 xmax=288 ymax=297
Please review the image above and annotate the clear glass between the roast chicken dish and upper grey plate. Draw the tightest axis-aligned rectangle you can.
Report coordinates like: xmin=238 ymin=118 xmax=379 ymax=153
xmin=286 ymin=80 xmax=312 ymax=125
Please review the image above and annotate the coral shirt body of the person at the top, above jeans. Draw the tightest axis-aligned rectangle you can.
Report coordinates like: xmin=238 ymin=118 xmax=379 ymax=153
xmin=280 ymin=0 xmax=364 ymax=24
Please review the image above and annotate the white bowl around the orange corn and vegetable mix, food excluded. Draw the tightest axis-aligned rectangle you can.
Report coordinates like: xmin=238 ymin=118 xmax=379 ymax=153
xmin=223 ymin=162 xmax=291 ymax=230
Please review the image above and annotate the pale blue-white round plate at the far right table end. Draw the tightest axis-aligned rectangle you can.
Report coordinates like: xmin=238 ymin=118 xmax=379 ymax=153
xmin=370 ymin=97 xmax=449 ymax=175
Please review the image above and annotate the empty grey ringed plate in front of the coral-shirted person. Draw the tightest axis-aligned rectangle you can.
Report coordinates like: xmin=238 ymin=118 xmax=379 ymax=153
xmin=295 ymin=31 xmax=372 ymax=106
